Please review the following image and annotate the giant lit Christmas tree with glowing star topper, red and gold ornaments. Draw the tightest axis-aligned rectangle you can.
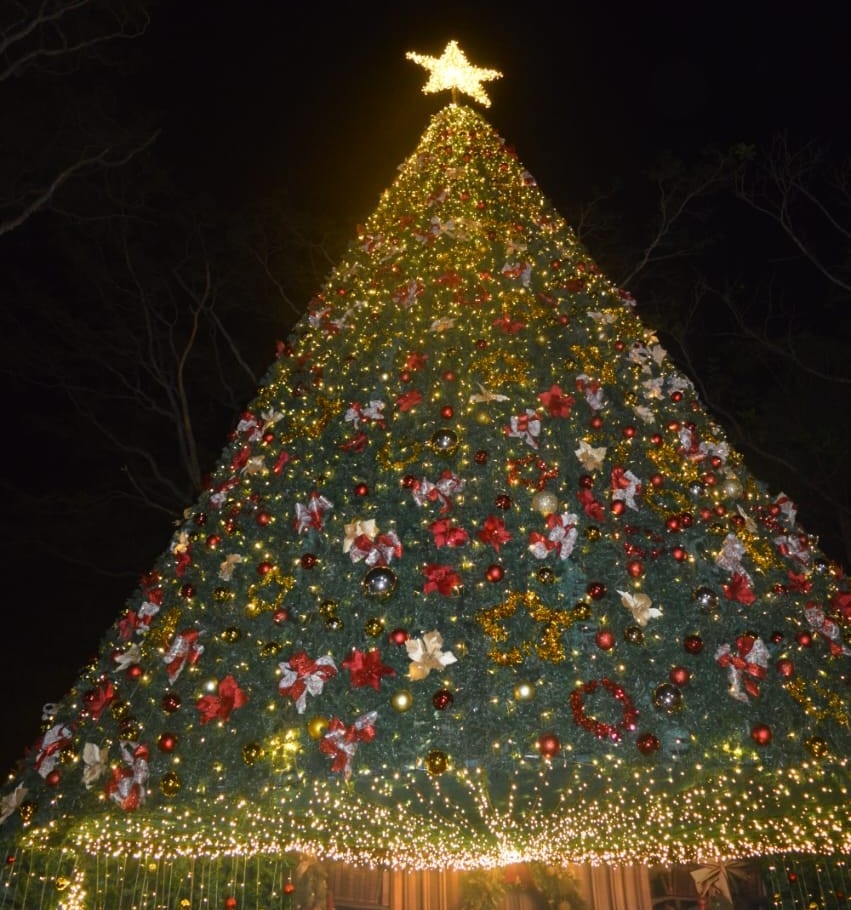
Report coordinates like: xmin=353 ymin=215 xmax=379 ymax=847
xmin=0 ymin=43 xmax=851 ymax=908
